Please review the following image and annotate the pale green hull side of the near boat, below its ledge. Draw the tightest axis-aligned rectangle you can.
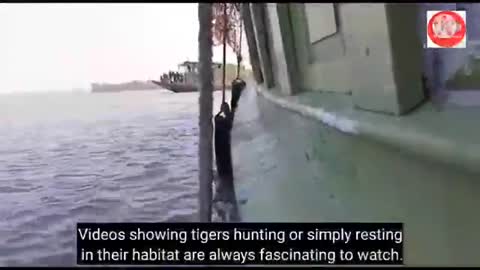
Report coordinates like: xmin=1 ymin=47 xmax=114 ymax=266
xmin=232 ymin=86 xmax=480 ymax=266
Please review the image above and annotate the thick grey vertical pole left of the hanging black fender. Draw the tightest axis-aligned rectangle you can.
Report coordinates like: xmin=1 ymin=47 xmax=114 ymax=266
xmin=198 ymin=3 xmax=213 ymax=222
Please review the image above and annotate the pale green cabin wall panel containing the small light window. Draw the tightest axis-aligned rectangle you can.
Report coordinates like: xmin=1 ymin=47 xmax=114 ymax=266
xmin=288 ymin=3 xmax=354 ymax=93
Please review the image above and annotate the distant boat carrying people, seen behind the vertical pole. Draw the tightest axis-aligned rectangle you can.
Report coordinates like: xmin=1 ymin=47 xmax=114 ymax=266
xmin=152 ymin=61 xmax=248 ymax=93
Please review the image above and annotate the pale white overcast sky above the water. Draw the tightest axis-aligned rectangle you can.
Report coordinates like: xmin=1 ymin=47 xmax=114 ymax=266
xmin=0 ymin=3 xmax=248 ymax=92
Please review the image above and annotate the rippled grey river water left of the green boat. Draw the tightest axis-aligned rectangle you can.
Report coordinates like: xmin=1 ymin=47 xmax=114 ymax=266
xmin=0 ymin=90 xmax=228 ymax=266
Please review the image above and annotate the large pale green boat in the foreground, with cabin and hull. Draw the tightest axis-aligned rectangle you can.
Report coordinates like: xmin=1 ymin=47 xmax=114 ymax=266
xmin=202 ymin=3 xmax=480 ymax=266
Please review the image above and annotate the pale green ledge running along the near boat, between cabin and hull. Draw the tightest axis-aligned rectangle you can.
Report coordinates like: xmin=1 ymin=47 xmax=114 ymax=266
xmin=255 ymin=85 xmax=480 ymax=176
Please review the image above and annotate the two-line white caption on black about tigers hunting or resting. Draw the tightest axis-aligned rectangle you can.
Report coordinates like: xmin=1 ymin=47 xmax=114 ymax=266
xmin=77 ymin=223 xmax=403 ymax=265
